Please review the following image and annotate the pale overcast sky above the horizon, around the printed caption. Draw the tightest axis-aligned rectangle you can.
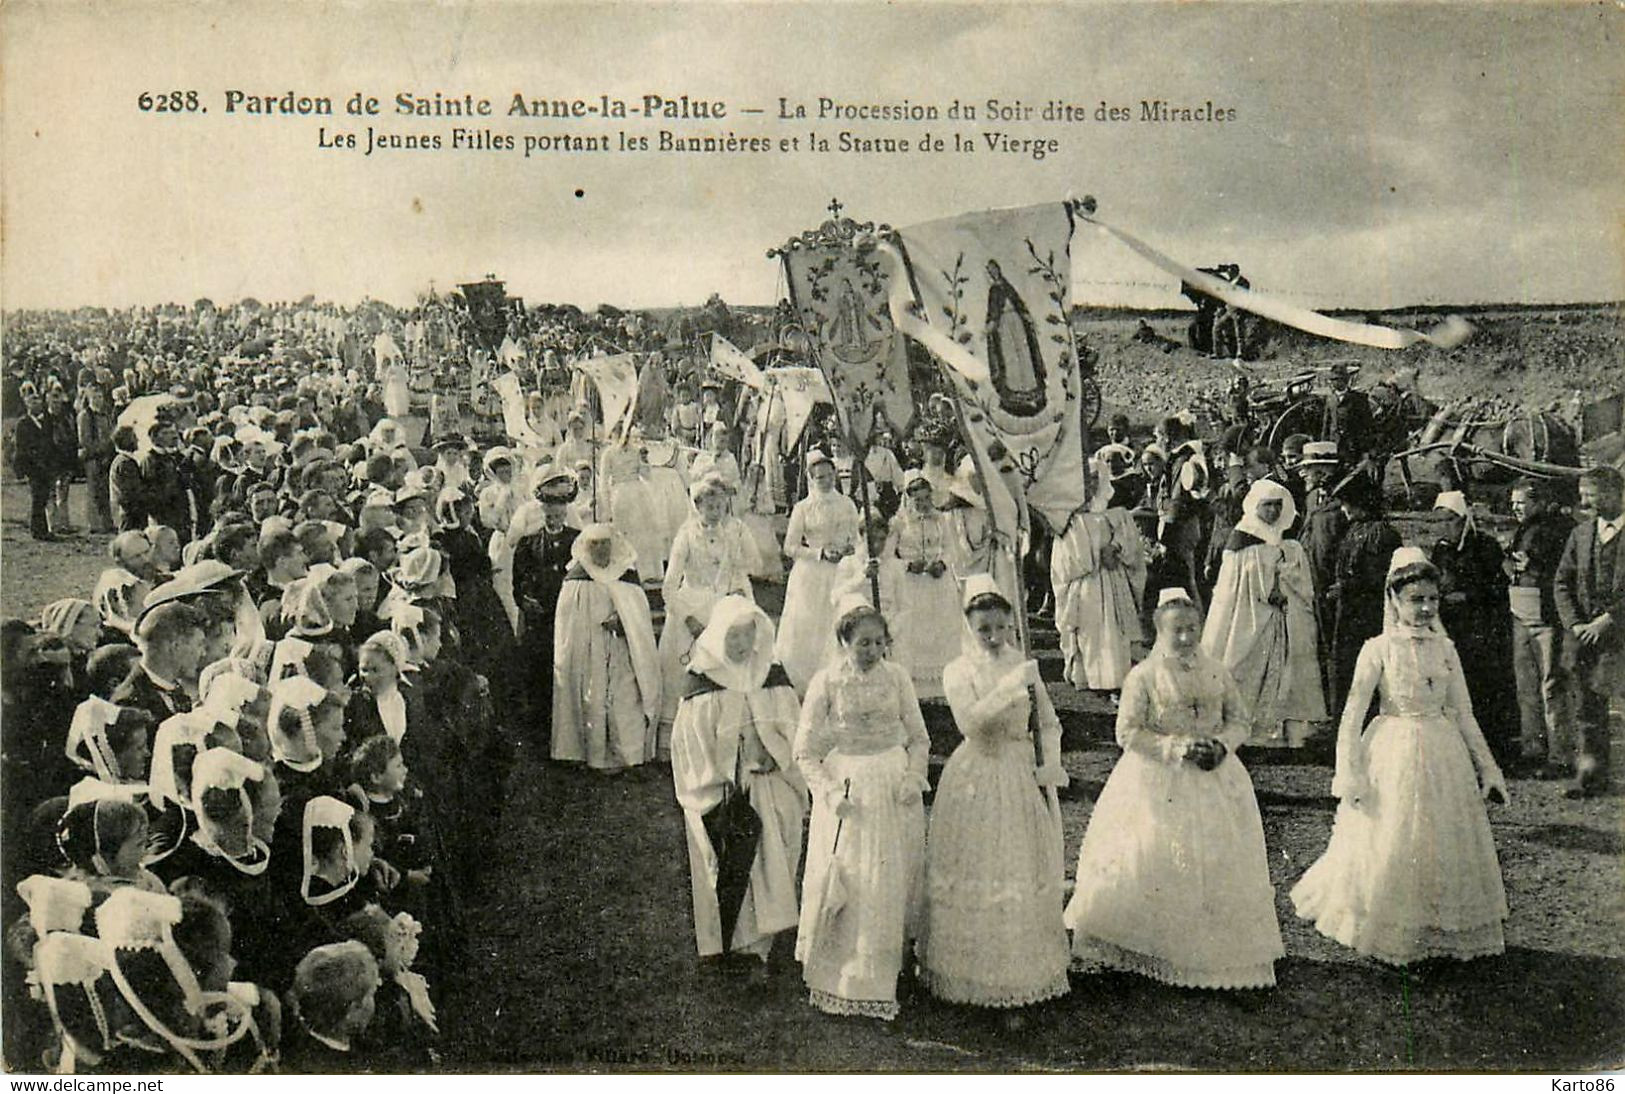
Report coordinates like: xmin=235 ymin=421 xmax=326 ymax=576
xmin=0 ymin=2 xmax=1625 ymax=309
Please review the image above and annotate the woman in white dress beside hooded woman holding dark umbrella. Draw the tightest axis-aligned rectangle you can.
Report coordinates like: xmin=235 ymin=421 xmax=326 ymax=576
xmin=795 ymin=597 xmax=931 ymax=1021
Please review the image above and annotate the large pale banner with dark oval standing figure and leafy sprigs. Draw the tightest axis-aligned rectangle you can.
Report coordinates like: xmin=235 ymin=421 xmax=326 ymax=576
xmin=887 ymin=202 xmax=1084 ymax=532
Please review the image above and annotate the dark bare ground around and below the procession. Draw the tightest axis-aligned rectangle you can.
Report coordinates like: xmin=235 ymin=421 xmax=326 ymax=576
xmin=0 ymin=484 xmax=1625 ymax=1071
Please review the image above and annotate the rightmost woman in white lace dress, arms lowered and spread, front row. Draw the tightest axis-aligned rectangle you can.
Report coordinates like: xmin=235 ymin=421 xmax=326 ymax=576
xmin=1292 ymin=548 xmax=1506 ymax=966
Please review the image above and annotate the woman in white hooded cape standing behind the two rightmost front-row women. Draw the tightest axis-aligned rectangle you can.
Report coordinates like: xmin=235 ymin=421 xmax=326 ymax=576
xmin=1203 ymin=478 xmax=1326 ymax=748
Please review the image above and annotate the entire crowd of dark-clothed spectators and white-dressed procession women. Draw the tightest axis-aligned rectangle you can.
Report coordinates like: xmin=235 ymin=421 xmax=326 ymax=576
xmin=0 ymin=295 xmax=1625 ymax=1071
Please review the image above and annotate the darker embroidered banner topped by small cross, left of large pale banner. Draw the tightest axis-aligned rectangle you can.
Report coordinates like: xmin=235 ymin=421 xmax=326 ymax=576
xmin=780 ymin=221 xmax=915 ymax=445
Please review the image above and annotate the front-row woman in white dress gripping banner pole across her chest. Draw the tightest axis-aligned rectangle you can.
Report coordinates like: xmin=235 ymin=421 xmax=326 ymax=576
xmin=915 ymin=574 xmax=1068 ymax=1008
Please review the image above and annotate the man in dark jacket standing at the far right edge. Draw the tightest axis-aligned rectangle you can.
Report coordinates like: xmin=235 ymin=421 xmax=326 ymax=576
xmin=1552 ymin=467 xmax=1625 ymax=798
